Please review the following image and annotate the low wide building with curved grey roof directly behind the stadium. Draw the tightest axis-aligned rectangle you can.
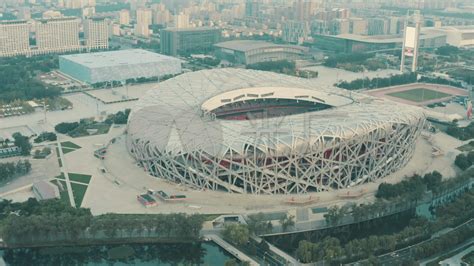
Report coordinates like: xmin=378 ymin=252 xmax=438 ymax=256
xmin=214 ymin=40 xmax=309 ymax=65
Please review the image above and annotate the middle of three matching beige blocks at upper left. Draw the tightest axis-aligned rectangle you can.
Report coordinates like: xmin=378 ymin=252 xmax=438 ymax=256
xmin=36 ymin=17 xmax=81 ymax=53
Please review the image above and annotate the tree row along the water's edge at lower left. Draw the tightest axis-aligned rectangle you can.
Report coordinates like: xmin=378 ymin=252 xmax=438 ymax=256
xmin=0 ymin=199 xmax=203 ymax=246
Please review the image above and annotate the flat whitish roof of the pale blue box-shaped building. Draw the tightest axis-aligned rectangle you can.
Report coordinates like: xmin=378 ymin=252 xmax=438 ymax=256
xmin=60 ymin=49 xmax=179 ymax=68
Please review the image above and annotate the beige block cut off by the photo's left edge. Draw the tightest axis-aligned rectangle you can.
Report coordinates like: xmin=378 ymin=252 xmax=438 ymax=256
xmin=0 ymin=20 xmax=30 ymax=57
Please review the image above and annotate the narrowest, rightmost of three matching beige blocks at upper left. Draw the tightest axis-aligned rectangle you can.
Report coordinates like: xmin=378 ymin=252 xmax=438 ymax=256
xmin=84 ymin=18 xmax=109 ymax=50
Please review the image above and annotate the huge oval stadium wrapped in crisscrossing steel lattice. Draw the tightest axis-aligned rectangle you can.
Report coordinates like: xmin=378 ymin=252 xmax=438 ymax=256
xmin=127 ymin=69 xmax=426 ymax=194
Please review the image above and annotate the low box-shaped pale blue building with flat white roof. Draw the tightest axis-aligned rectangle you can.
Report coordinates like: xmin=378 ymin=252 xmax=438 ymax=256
xmin=59 ymin=49 xmax=181 ymax=84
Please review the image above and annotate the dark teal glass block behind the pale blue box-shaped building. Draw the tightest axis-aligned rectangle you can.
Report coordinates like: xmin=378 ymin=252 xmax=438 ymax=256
xmin=161 ymin=27 xmax=221 ymax=55
